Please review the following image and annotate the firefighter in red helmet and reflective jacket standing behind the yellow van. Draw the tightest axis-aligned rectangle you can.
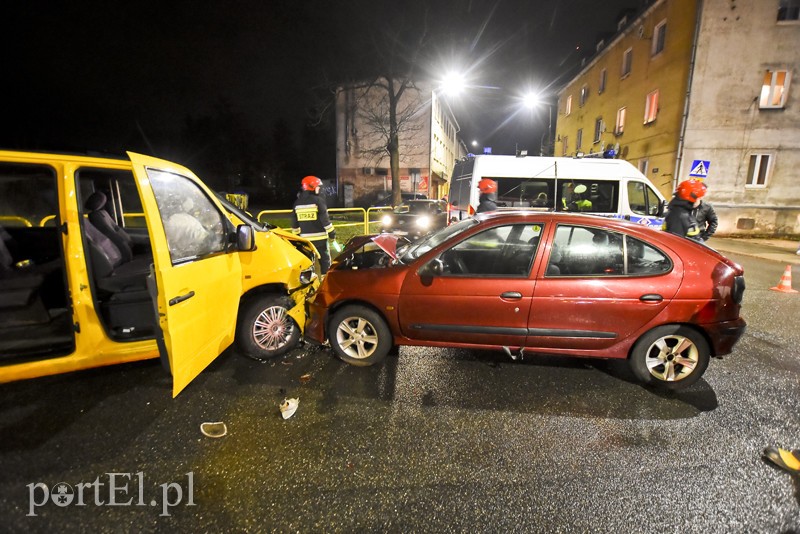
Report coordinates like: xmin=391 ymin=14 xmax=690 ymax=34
xmin=292 ymin=176 xmax=336 ymax=274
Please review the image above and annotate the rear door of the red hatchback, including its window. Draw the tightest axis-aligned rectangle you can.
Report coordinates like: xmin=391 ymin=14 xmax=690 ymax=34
xmin=526 ymin=225 xmax=683 ymax=351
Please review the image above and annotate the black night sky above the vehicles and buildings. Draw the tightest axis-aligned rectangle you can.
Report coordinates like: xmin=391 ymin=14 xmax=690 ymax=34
xmin=0 ymin=0 xmax=642 ymax=176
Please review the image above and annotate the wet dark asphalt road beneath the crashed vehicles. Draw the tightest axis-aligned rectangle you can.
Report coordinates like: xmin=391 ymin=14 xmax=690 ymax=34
xmin=0 ymin=255 xmax=800 ymax=533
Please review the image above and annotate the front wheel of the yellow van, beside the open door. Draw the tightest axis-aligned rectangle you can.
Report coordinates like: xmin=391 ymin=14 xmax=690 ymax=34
xmin=236 ymin=295 xmax=300 ymax=361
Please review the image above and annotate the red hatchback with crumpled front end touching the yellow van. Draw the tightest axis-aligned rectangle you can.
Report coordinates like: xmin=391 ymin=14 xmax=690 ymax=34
xmin=306 ymin=212 xmax=745 ymax=389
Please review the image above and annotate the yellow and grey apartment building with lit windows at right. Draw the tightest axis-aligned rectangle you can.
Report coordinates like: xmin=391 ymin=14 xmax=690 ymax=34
xmin=556 ymin=0 xmax=800 ymax=235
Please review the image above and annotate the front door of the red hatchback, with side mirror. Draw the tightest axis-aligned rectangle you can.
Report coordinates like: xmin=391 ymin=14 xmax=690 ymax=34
xmin=399 ymin=224 xmax=541 ymax=347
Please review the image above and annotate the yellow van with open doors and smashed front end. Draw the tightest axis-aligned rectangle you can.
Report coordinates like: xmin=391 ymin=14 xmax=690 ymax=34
xmin=0 ymin=151 xmax=319 ymax=396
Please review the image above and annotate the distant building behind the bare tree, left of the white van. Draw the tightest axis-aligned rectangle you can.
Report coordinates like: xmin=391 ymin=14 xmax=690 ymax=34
xmin=336 ymin=80 xmax=466 ymax=206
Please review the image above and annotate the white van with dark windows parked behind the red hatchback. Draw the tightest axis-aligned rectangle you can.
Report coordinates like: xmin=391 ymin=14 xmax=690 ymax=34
xmin=449 ymin=154 xmax=666 ymax=228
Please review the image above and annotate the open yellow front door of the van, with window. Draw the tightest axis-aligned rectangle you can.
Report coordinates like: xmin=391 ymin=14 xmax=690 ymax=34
xmin=128 ymin=152 xmax=242 ymax=397
